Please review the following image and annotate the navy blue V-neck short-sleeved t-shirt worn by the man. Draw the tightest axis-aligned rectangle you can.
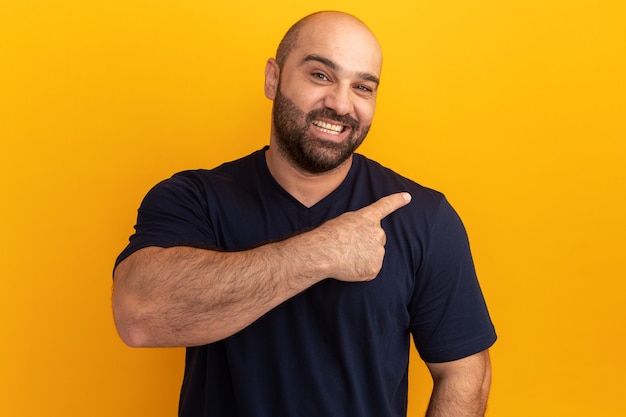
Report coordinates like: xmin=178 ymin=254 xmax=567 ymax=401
xmin=117 ymin=148 xmax=496 ymax=417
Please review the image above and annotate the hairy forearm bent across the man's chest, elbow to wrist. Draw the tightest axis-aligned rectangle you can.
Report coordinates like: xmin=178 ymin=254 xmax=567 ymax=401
xmin=113 ymin=239 xmax=322 ymax=346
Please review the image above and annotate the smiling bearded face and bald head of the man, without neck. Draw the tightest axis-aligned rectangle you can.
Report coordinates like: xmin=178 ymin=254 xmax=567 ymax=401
xmin=265 ymin=12 xmax=381 ymax=174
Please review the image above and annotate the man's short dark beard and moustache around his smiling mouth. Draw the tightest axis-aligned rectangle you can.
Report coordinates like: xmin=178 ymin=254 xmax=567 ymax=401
xmin=272 ymin=87 xmax=370 ymax=174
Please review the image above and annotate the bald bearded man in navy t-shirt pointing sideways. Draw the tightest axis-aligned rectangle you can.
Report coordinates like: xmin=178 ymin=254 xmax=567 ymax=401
xmin=113 ymin=12 xmax=496 ymax=417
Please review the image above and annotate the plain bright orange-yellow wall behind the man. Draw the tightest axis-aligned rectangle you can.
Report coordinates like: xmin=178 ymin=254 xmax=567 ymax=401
xmin=0 ymin=0 xmax=626 ymax=417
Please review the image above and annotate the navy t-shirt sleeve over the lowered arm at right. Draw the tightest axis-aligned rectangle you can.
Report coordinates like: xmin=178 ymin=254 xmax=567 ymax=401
xmin=411 ymin=199 xmax=496 ymax=363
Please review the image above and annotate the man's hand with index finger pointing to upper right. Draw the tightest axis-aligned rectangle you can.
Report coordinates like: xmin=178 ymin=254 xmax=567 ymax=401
xmin=312 ymin=193 xmax=411 ymax=282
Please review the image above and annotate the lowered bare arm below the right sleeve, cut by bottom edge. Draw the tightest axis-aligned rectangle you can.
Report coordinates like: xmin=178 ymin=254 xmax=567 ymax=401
xmin=426 ymin=350 xmax=491 ymax=417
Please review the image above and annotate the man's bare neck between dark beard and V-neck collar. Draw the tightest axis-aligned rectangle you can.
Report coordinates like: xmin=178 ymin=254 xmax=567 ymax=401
xmin=265 ymin=145 xmax=352 ymax=207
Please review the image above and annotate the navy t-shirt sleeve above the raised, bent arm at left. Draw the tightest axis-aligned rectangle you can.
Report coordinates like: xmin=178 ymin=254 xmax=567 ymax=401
xmin=115 ymin=173 xmax=215 ymax=266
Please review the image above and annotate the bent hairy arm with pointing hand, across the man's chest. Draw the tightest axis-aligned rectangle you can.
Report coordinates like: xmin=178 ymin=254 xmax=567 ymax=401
xmin=113 ymin=193 xmax=409 ymax=346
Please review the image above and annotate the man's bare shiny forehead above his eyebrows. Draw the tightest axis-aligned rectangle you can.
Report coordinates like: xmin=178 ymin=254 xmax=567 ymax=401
xmin=287 ymin=17 xmax=382 ymax=77
